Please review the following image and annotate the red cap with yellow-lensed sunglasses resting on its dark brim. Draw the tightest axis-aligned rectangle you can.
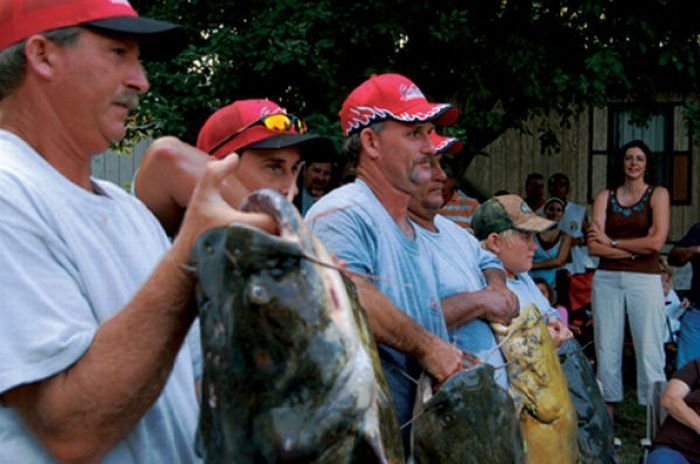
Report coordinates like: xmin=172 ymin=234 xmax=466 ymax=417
xmin=197 ymin=99 xmax=336 ymax=158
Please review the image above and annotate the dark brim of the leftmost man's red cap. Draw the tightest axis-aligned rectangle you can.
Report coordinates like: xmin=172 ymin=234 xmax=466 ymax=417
xmin=82 ymin=16 xmax=187 ymax=61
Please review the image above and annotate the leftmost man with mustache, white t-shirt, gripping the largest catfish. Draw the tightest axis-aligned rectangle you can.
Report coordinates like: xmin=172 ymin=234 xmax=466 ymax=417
xmin=0 ymin=0 xmax=276 ymax=464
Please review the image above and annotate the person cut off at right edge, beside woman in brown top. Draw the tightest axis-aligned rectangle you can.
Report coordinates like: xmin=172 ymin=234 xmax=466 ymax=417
xmin=668 ymin=222 xmax=700 ymax=372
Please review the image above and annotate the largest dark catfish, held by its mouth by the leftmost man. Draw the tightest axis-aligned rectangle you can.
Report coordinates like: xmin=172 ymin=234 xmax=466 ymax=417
xmin=193 ymin=190 xmax=403 ymax=464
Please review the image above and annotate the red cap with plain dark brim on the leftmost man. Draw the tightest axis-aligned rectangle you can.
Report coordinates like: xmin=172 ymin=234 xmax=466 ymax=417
xmin=0 ymin=0 xmax=186 ymax=59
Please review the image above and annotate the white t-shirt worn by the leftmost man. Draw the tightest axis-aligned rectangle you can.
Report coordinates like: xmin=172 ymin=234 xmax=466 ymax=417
xmin=0 ymin=130 xmax=199 ymax=464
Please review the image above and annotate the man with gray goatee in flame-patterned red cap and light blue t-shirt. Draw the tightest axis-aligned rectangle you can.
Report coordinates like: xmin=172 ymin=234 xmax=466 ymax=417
xmin=306 ymin=74 xmax=474 ymax=445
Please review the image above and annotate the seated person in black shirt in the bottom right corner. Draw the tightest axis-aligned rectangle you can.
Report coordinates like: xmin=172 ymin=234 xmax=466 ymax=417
xmin=647 ymin=358 xmax=700 ymax=464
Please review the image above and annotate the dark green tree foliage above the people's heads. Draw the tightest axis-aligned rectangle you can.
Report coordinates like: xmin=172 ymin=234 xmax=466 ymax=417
xmin=132 ymin=0 xmax=700 ymax=167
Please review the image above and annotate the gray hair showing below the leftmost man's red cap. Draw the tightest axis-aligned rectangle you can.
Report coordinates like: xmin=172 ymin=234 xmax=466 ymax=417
xmin=0 ymin=26 xmax=82 ymax=100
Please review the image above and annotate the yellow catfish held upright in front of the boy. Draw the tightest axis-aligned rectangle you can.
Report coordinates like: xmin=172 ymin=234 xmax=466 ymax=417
xmin=493 ymin=304 xmax=579 ymax=464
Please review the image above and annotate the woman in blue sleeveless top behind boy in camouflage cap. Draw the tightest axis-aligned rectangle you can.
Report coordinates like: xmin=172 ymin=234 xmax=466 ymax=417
xmin=530 ymin=197 xmax=572 ymax=290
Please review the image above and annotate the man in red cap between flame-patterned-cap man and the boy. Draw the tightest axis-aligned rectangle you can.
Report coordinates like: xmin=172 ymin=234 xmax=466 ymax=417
xmin=408 ymin=132 xmax=519 ymax=388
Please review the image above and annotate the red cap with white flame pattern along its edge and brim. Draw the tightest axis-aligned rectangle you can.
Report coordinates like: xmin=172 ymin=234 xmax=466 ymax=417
xmin=339 ymin=74 xmax=459 ymax=137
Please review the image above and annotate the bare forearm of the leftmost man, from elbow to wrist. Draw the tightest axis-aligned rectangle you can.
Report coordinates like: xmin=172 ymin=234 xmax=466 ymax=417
xmin=3 ymin=245 xmax=195 ymax=461
